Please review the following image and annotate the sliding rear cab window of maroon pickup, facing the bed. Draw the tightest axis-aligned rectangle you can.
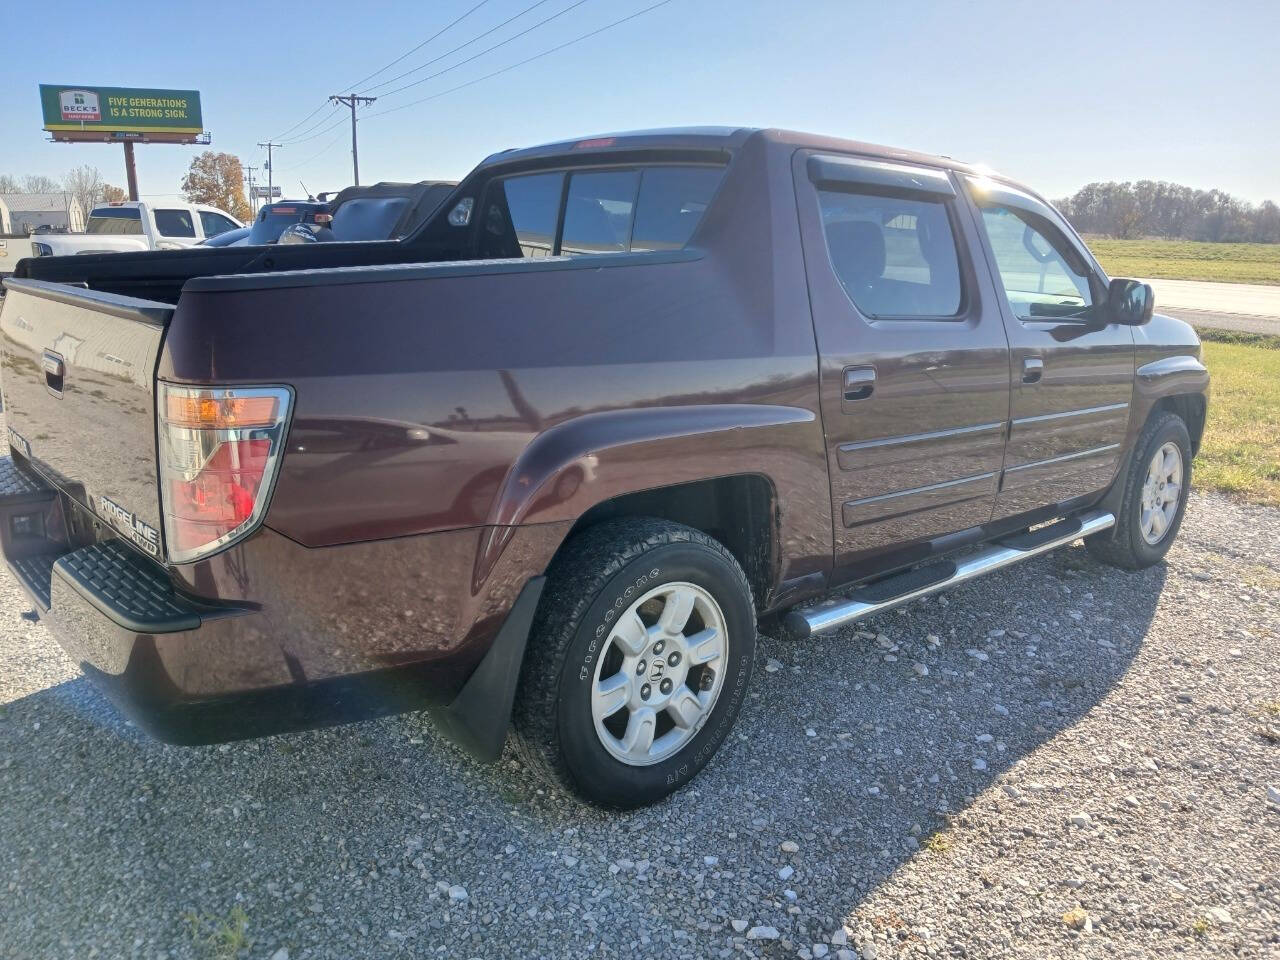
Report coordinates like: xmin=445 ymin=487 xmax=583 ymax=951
xmin=480 ymin=164 xmax=724 ymax=259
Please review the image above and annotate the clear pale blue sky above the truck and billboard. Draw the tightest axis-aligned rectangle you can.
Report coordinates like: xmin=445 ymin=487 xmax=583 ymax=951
xmin=0 ymin=0 xmax=1280 ymax=209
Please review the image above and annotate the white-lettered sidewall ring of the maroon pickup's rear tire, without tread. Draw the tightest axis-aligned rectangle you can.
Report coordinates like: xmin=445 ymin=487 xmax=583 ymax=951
xmin=557 ymin=541 xmax=755 ymax=806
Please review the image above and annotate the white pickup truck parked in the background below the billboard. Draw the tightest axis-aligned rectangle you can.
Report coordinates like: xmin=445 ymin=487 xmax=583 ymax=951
xmin=31 ymin=201 xmax=243 ymax=256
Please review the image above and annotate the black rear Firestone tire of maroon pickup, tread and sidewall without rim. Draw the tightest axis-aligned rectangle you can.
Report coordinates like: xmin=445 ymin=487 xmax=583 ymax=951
xmin=512 ymin=517 xmax=755 ymax=809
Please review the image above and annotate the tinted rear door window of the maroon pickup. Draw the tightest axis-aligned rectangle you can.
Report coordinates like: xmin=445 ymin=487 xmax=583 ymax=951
xmin=818 ymin=191 xmax=960 ymax=317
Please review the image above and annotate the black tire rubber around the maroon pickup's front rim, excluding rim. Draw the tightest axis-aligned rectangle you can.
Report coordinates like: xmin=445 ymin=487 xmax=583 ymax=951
xmin=1084 ymin=412 xmax=1192 ymax=570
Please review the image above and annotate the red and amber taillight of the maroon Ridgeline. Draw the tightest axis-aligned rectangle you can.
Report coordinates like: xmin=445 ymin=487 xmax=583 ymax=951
xmin=156 ymin=380 xmax=292 ymax=563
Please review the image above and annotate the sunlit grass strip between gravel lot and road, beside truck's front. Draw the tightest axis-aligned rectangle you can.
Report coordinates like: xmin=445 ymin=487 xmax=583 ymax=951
xmin=1193 ymin=339 xmax=1280 ymax=506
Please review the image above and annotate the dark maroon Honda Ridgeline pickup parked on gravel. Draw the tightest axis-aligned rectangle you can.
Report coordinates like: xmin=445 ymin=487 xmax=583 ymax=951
xmin=0 ymin=128 xmax=1208 ymax=806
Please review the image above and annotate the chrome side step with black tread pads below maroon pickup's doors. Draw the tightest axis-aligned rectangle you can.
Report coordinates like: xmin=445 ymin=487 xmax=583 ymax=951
xmin=783 ymin=511 xmax=1116 ymax=640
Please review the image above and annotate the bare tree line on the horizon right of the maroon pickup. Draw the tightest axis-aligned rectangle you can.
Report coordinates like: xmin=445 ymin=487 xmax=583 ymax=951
xmin=1055 ymin=180 xmax=1280 ymax=243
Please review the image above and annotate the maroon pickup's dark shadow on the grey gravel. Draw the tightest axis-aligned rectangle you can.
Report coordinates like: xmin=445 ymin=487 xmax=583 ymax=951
xmin=0 ymin=547 xmax=1166 ymax=956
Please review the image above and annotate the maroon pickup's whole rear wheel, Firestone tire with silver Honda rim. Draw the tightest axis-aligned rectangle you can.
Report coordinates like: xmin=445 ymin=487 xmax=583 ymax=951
xmin=513 ymin=518 xmax=755 ymax=808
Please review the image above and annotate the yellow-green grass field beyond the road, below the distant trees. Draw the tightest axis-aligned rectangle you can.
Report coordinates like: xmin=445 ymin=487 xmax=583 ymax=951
xmin=1085 ymin=237 xmax=1280 ymax=284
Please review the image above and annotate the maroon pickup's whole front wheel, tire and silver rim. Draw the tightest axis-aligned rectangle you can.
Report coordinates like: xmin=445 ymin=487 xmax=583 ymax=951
xmin=1084 ymin=413 xmax=1192 ymax=570
